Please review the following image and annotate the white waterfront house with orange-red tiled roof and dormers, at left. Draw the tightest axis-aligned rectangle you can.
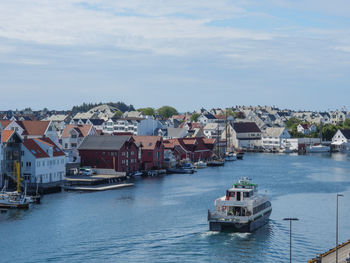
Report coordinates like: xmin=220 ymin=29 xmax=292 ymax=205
xmin=21 ymin=138 xmax=66 ymax=184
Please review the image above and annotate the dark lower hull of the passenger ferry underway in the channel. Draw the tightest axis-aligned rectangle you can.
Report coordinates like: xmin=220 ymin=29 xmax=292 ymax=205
xmin=209 ymin=210 xmax=272 ymax=233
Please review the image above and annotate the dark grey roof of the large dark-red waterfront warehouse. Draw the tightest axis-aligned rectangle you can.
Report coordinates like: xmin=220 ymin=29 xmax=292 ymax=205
xmin=79 ymin=135 xmax=132 ymax=150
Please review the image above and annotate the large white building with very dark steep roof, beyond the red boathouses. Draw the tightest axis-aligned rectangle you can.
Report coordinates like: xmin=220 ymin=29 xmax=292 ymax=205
xmin=230 ymin=122 xmax=261 ymax=149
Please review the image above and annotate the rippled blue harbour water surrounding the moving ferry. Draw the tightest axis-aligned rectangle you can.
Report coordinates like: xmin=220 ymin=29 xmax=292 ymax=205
xmin=0 ymin=154 xmax=350 ymax=262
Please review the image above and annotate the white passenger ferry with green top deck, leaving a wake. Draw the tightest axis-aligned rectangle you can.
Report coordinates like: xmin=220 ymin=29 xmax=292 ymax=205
xmin=208 ymin=178 xmax=272 ymax=232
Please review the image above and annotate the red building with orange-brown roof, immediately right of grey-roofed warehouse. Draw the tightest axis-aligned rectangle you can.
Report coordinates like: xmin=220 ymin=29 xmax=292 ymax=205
xmin=133 ymin=136 xmax=164 ymax=170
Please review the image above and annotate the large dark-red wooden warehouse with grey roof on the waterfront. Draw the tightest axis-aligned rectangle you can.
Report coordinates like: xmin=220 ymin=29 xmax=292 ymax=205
xmin=78 ymin=135 xmax=139 ymax=173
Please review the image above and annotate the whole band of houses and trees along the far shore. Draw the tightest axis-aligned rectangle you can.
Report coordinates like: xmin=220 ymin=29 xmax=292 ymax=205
xmin=0 ymin=103 xmax=350 ymax=192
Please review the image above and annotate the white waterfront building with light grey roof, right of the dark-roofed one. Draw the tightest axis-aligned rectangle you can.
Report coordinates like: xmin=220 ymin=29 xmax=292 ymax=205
xmin=261 ymin=127 xmax=291 ymax=149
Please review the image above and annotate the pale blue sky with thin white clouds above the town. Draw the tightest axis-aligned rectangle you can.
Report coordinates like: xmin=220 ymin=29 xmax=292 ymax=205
xmin=0 ymin=0 xmax=350 ymax=111
